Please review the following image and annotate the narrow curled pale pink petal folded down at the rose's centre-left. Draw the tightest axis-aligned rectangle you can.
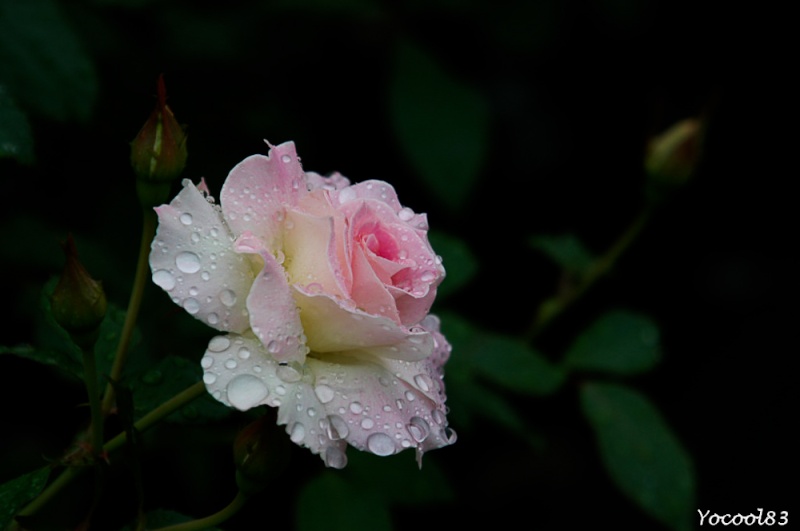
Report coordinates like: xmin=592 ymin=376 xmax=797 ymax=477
xmin=235 ymin=232 xmax=308 ymax=362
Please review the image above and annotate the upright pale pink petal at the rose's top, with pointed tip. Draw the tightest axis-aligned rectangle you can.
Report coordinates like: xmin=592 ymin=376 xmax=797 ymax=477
xmin=220 ymin=142 xmax=308 ymax=248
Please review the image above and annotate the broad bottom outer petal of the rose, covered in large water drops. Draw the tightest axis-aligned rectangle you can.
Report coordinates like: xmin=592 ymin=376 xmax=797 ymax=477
xmin=201 ymin=324 xmax=455 ymax=468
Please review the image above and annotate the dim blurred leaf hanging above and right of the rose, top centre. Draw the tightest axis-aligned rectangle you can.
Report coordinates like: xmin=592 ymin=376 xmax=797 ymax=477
xmin=390 ymin=41 xmax=489 ymax=210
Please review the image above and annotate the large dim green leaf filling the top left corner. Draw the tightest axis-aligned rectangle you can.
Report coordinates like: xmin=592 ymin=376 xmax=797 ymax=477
xmin=0 ymin=0 xmax=97 ymax=120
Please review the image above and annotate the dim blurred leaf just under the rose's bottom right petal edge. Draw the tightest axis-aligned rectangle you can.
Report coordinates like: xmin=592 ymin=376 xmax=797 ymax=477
xmin=344 ymin=451 xmax=455 ymax=505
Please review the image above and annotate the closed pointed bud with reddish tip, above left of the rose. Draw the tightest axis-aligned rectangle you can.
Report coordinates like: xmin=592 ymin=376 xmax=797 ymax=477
xmin=131 ymin=75 xmax=187 ymax=206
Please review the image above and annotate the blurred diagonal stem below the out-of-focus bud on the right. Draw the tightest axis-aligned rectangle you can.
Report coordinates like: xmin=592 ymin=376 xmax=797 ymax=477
xmin=526 ymin=206 xmax=653 ymax=339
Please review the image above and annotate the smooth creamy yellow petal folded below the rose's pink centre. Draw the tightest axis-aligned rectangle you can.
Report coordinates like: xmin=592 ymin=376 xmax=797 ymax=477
xmin=293 ymin=286 xmax=433 ymax=361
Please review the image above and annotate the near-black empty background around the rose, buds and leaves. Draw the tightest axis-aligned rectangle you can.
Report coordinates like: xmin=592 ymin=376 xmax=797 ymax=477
xmin=0 ymin=0 xmax=800 ymax=529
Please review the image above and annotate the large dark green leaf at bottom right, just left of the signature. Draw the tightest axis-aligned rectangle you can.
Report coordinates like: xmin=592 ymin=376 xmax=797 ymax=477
xmin=581 ymin=383 xmax=695 ymax=531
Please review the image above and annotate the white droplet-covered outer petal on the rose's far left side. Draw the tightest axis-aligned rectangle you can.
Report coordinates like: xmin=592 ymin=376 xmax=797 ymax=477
xmin=150 ymin=179 xmax=255 ymax=332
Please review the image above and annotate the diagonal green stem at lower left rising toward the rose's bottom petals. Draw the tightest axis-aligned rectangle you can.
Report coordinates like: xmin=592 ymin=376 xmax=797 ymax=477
xmin=18 ymin=382 xmax=205 ymax=516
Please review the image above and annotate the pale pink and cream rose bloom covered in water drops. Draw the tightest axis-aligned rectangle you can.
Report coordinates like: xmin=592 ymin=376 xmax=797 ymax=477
xmin=150 ymin=142 xmax=455 ymax=468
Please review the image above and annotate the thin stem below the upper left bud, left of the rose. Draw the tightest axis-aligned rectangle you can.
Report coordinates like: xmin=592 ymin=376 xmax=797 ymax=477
xmin=103 ymin=208 xmax=157 ymax=414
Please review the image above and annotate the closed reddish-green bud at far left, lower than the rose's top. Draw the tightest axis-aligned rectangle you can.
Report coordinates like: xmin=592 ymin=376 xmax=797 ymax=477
xmin=50 ymin=234 xmax=106 ymax=346
